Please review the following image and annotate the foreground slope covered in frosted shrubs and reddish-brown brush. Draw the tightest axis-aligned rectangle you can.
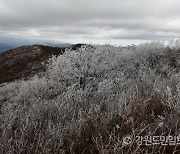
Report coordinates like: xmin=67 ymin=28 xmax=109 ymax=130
xmin=0 ymin=42 xmax=180 ymax=154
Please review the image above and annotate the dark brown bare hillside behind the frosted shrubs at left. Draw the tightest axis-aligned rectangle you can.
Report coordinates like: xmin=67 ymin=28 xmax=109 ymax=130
xmin=0 ymin=44 xmax=87 ymax=84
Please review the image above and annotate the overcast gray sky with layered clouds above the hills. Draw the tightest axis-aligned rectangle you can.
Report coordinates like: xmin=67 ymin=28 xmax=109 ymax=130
xmin=0 ymin=0 xmax=180 ymax=44
